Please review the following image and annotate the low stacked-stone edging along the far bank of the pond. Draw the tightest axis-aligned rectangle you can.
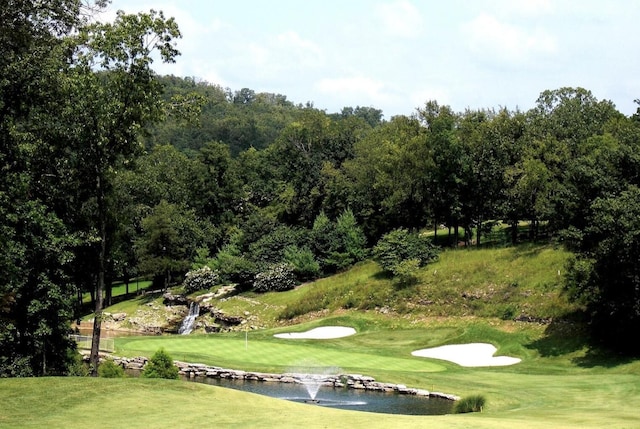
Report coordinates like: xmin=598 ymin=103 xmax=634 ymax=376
xmin=107 ymin=356 xmax=460 ymax=401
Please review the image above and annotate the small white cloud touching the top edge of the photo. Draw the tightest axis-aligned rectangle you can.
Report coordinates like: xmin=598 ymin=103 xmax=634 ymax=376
xmin=375 ymin=0 xmax=423 ymax=38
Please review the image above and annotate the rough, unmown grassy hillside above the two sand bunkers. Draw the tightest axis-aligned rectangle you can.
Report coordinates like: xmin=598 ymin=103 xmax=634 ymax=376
xmin=209 ymin=244 xmax=576 ymax=326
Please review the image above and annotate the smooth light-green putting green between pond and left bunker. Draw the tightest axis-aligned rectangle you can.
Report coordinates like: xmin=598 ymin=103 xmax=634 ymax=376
xmin=116 ymin=320 xmax=451 ymax=372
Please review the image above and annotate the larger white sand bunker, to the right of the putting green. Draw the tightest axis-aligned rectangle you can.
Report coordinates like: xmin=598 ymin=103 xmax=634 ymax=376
xmin=411 ymin=343 xmax=520 ymax=367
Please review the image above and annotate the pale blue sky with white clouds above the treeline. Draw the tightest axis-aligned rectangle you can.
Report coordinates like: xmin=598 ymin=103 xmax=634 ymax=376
xmin=107 ymin=0 xmax=640 ymax=119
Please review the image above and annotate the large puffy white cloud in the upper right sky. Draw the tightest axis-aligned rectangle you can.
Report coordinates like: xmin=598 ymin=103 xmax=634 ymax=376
xmin=463 ymin=13 xmax=557 ymax=65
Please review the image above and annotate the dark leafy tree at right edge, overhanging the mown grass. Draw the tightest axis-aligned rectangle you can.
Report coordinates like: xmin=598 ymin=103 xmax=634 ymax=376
xmin=566 ymin=185 xmax=640 ymax=354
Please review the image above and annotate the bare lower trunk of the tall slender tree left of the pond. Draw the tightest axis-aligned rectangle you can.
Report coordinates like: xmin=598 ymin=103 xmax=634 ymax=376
xmin=89 ymin=174 xmax=107 ymax=377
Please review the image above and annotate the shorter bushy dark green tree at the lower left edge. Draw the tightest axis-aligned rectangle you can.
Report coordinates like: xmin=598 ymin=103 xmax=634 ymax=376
xmin=0 ymin=201 xmax=77 ymax=377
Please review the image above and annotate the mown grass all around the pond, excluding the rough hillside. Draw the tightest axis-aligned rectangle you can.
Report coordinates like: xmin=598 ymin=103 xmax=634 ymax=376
xmin=0 ymin=318 xmax=640 ymax=429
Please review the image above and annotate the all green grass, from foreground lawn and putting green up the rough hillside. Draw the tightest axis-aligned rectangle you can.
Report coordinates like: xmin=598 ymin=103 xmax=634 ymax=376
xmin=5 ymin=244 xmax=640 ymax=429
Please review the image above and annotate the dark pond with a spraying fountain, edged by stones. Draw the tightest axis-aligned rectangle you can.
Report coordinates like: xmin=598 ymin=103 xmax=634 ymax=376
xmin=185 ymin=377 xmax=454 ymax=415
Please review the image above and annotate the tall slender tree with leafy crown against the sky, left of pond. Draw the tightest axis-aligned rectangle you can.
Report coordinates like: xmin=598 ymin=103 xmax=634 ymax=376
xmin=60 ymin=11 xmax=180 ymax=370
